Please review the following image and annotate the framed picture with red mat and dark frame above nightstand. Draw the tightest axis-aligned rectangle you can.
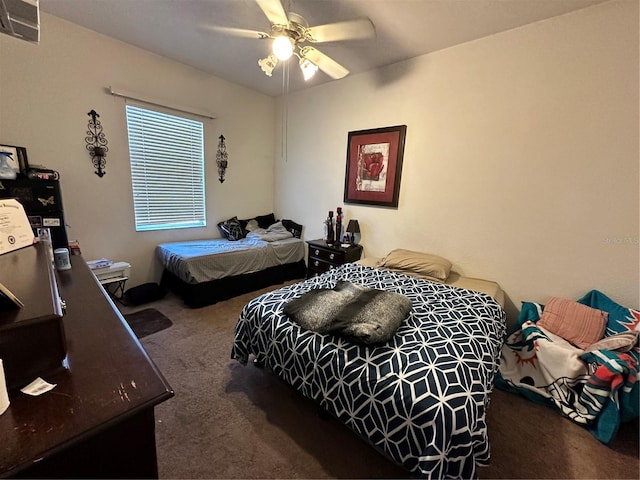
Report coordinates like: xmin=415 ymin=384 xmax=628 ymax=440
xmin=344 ymin=125 xmax=407 ymax=208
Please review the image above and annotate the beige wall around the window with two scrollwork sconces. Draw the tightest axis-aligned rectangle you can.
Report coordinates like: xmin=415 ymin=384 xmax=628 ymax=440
xmin=0 ymin=13 xmax=275 ymax=286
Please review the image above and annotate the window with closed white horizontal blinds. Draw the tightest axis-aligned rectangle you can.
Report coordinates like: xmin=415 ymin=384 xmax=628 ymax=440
xmin=127 ymin=105 xmax=207 ymax=231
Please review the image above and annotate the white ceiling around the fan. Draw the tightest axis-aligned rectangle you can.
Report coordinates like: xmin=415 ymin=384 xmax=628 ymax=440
xmin=40 ymin=0 xmax=606 ymax=96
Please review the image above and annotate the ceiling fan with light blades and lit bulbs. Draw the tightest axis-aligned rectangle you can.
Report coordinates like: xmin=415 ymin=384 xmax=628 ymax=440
xmin=222 ymin=0 xmax=375 ymax=80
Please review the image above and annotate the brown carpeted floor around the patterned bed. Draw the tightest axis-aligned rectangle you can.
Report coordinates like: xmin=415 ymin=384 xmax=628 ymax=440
xmin=121 ymin=289 xmax=640 ymax=479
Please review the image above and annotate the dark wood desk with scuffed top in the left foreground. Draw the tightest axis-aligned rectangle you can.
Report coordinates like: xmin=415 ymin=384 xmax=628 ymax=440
xmin=0 ymin=251 xmax=173 ymax=478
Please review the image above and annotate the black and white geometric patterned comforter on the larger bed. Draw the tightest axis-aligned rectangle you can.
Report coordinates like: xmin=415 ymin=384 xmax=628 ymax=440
xmin=231 ymin=264 xmax=505 ymax=478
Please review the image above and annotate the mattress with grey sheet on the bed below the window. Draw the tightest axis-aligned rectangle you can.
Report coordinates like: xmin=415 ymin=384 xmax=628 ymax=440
xmin=156 ymin=238 xmax=304 ymax=284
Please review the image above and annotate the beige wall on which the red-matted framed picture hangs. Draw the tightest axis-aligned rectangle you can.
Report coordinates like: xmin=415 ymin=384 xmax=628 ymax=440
xmin=276 ymin=0 xmax=640 ymax=319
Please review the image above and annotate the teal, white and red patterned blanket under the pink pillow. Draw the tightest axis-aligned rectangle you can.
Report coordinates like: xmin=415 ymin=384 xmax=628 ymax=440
xmin=496 ymin=290 xmax=640 ymax=443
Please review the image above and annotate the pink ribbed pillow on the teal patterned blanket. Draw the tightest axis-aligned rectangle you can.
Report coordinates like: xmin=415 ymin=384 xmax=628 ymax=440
xmin=537 ymin=297 xmax=609 ymax=350
